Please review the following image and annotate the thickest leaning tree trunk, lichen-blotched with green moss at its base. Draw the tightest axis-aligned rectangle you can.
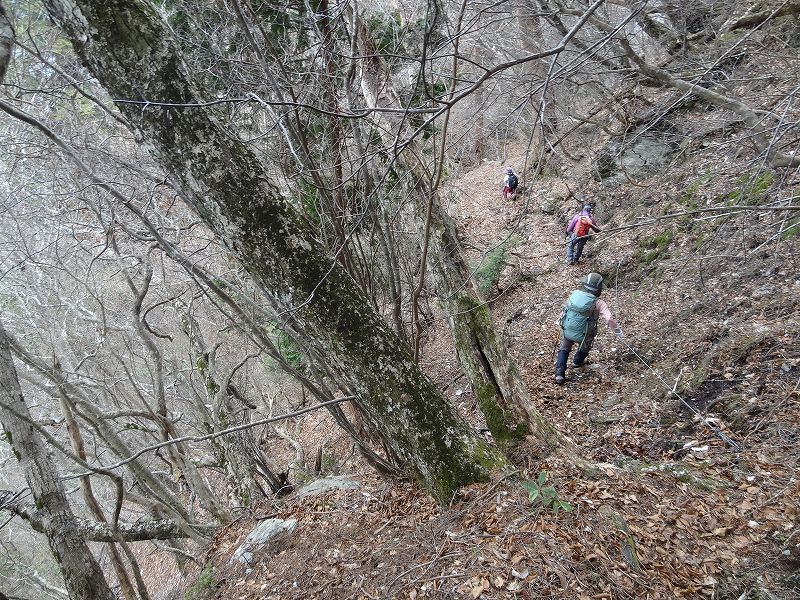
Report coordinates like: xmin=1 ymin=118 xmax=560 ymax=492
xmin=40 ymin=0 xmax=506 ymax=502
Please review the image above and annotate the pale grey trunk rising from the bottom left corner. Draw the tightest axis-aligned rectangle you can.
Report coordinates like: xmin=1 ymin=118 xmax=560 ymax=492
xmin=0 ymin=322 xmax=114 ymax=600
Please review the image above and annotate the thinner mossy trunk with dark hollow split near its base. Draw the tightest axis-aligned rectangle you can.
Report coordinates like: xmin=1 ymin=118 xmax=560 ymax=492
xmin=354 ymin=9 xmax=573 ymax=449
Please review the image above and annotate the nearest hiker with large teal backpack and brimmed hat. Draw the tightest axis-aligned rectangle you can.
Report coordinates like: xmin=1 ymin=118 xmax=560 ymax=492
xmin=556 ymin=273 xmax=625 ymax=385
